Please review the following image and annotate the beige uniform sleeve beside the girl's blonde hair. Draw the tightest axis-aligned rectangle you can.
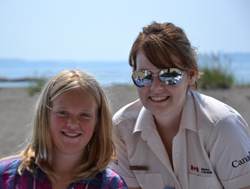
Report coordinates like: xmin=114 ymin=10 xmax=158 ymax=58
xmin=110 ymin=119 xmax=140 ymax=188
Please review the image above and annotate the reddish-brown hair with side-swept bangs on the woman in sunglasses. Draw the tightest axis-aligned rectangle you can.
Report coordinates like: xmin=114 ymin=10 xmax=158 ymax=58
xmin=129 ymin=22 xmax=200 ymax=89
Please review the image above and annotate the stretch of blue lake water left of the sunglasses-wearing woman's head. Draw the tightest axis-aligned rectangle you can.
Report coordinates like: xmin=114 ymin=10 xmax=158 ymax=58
xmin=0 ymin=60 xmax=132 ymax=87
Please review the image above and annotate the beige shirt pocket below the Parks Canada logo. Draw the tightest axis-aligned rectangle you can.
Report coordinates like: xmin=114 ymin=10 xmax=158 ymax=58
xmin=188 ymin=174 xmax=223 ymax=189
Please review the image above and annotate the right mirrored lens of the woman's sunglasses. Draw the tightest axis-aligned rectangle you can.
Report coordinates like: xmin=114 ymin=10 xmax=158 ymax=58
xmin=159 ymin=68 xmax=182 ymax=85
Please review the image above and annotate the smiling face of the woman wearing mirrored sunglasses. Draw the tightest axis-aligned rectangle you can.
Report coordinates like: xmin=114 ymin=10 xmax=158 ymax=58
xmin=136 ymin=51 xmax=195 ymax=118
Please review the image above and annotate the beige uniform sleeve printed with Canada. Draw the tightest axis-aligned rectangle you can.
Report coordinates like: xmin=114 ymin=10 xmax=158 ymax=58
xmin=208 ymin=114 xmax=250 ymax=189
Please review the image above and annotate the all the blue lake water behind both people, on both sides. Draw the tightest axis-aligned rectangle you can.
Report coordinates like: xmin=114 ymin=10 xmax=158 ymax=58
xmin=0 ymin=53 xmax=250 ymax=87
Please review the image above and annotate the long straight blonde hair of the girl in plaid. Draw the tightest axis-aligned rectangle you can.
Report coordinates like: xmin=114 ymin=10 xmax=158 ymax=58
xmin=1 ymin=69 xmax=115 ymax=182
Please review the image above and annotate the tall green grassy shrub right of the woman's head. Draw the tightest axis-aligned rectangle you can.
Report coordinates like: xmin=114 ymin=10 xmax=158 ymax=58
xmin=198 ymin=53 xmax=234 ymax=89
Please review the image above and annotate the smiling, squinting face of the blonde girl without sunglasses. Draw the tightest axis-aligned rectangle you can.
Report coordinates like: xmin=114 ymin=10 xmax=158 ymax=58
xmin=50 ymin=89 xmax=97 ymax=158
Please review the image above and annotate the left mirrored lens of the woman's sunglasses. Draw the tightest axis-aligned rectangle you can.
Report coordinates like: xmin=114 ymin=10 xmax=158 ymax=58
xmin=132 ymin=70 xmax=153 ymax=88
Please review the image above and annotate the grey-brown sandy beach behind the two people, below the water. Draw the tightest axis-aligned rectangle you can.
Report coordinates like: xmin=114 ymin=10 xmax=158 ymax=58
xmin=0 ymin=85 xmax=250 ymax=158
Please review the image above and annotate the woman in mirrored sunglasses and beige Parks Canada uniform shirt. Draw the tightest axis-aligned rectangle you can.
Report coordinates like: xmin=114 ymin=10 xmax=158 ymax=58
xmin=111 ymin=22 xmax=250 ymax=189
